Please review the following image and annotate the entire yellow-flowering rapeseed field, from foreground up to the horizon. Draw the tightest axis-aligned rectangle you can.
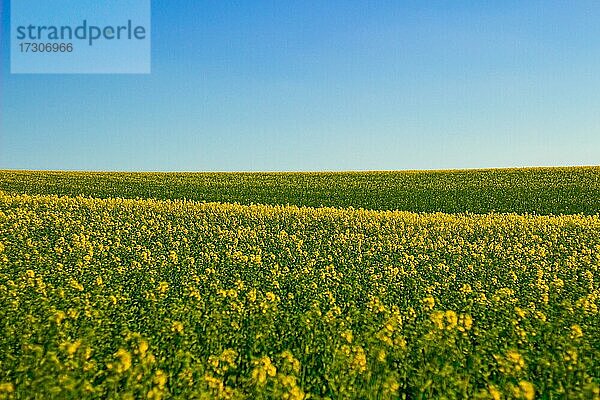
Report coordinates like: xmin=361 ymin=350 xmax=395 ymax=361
xmin=0 ymin=168 xmax=600 ymax=400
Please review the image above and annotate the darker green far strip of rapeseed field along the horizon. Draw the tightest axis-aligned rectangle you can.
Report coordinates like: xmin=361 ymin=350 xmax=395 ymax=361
xmin=0 ymin=167 xmax=600 ymax=215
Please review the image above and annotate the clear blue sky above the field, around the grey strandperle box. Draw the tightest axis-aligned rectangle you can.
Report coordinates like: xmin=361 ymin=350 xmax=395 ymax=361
xmin=0 ymin=0 xmax=600 ymax=171
